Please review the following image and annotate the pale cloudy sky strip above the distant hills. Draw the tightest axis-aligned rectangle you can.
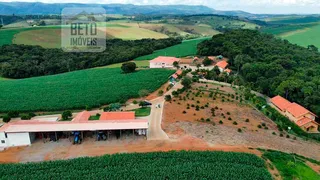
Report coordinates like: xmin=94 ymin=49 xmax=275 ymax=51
xmin=0 ymin=0 xmax=320 ymax=14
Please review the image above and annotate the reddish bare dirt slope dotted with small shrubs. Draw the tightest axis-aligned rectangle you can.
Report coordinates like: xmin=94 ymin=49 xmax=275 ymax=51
xmin=162 ymin=84 xmax=320 ymax=160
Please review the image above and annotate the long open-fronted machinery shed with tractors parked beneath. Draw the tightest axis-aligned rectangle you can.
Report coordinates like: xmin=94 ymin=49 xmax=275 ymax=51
xmin=0 ymin=111 xmax=148 ymax=148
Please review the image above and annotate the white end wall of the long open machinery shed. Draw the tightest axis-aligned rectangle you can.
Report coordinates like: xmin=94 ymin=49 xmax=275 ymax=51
xmin=7 ymin=133 xmax=31 ymax=146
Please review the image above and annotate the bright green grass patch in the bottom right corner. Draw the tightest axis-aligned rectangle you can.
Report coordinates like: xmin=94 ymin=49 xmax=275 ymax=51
xmin=263 ymin=151 xmax=320 ymax=180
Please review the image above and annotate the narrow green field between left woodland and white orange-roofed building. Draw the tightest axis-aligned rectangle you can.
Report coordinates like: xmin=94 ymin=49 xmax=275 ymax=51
xmin=135 ymin=37 xmax=210 ymax=60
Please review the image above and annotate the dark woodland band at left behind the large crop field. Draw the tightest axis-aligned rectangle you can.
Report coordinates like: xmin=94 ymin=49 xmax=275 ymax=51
xmin=0 ymin=38 xmax=181 ymax=79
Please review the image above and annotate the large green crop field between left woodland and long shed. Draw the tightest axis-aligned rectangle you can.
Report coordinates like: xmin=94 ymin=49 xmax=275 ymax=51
xmin=0 ymin=68 xmax=174 ymax=112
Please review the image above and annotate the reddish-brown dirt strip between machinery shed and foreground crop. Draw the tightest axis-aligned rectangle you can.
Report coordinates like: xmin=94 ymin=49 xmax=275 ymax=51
xmin=0 ymin=135 xmax=260 ymax=163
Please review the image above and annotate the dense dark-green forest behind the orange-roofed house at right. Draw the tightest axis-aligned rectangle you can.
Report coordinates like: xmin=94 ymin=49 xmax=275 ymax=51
xmin=198 ymin=30 xmax=320 ymax=114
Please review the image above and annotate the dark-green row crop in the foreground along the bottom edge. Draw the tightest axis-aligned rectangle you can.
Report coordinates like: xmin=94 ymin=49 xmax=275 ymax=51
xmin=0 ymin=151 xmax=272 ymax=180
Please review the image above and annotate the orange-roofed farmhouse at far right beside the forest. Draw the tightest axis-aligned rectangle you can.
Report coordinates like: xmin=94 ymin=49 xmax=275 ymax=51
xmin=271 ymin=96 xmax=319 ymax=132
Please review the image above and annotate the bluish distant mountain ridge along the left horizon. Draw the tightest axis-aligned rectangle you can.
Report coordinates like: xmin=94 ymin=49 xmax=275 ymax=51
xmin=0 ymin=2 xmax=214 ymax=15
